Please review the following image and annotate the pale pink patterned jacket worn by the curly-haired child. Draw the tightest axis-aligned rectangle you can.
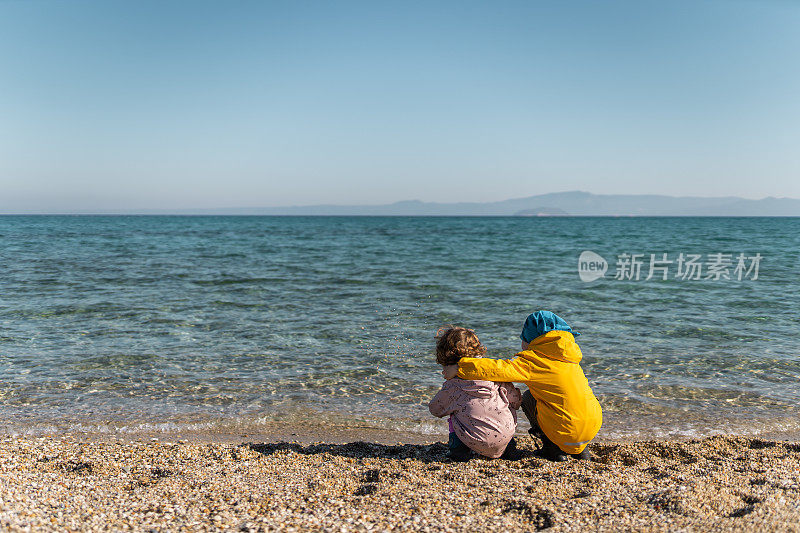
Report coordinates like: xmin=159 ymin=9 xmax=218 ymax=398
xmin=428 ymin=378 xmax=522 ymax=457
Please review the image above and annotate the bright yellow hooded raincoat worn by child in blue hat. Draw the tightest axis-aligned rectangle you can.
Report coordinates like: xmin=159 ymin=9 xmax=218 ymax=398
xmin=458 ymin=330 xmax=603 ymax=454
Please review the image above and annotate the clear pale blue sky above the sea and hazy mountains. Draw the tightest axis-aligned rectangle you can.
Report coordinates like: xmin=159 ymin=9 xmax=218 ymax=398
xmin=0 ymin=0 xmax=800 ymax=213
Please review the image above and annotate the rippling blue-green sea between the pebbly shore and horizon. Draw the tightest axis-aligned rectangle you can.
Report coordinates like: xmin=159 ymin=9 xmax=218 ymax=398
xmin=0 ymin=216 xmax=800 ymax=439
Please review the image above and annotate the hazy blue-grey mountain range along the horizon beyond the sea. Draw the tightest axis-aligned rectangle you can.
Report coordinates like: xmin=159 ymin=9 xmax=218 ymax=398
xmin=177 ymin=191 xmax=800 ymax=216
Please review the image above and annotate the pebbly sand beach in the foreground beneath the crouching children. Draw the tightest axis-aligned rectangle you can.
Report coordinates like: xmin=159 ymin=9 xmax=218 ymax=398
xmin=0 ymin=436 xmax=800 ymax=531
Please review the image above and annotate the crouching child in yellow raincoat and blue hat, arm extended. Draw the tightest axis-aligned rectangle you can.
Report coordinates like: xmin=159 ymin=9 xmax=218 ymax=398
xmin=442 ymin=311 xmax=603 ymax=461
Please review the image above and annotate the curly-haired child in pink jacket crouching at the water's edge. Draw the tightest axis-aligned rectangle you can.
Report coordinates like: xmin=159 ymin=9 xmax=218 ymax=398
xmin=428 ymin=328 xmax=522 ymax=461
